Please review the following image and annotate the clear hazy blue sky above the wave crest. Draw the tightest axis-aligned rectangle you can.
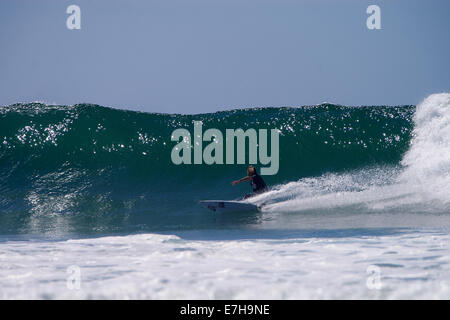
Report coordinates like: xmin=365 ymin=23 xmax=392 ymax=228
xmin=0 ymin=0 xmax=450 ymax=113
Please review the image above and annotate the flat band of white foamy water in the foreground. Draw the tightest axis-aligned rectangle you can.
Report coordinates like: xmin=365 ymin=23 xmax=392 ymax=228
xmin=0 ymin=232 xmax=450 ymax=299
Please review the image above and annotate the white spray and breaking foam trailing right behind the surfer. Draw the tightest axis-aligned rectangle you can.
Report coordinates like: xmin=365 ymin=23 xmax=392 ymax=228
xmin=251 ymin=93 xmax=450 ymax=213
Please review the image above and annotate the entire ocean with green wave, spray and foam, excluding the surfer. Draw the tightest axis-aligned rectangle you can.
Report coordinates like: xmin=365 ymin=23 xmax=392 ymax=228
xmin=0 ymin=93 xmax=450 ymax=299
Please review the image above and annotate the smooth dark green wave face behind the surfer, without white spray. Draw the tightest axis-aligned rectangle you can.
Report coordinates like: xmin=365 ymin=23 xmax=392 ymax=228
xmin=0 ymin=103 xmax=415 ymax=234
